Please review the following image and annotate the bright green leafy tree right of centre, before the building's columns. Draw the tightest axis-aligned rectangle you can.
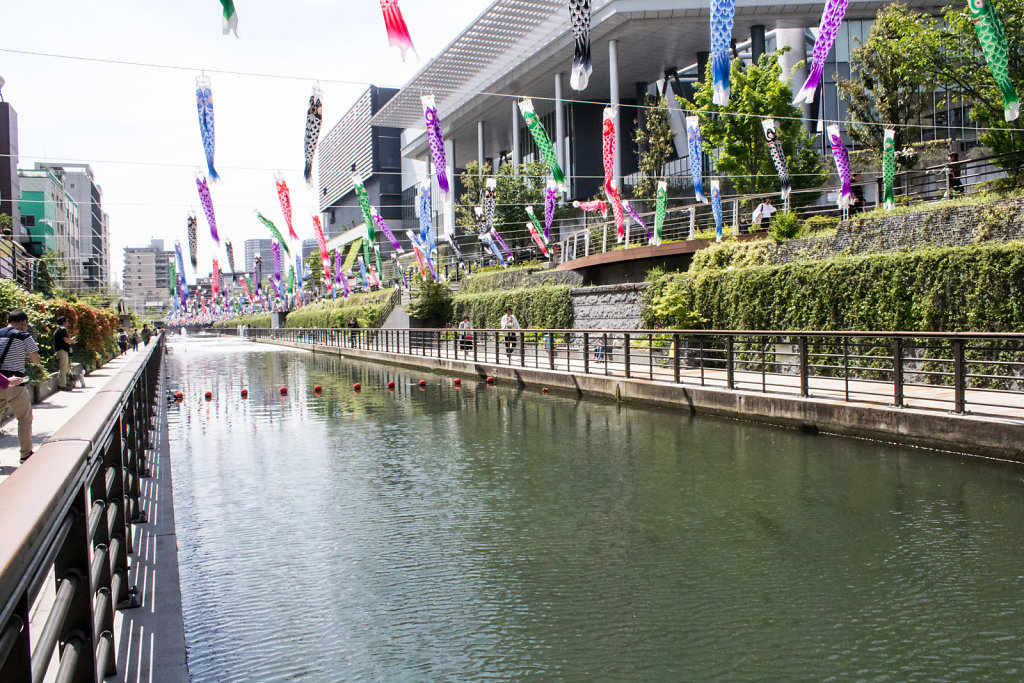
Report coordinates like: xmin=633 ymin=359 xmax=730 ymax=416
xmin=680 ymin=48 xmax=827 ymax=204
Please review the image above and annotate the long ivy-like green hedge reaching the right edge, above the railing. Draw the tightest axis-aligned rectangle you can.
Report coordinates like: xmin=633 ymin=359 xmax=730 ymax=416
xmin=644 ymin=243 xmax=1024 ymax=332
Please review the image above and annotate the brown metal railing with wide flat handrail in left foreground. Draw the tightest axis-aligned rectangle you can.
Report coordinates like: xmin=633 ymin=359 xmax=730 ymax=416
xmin=0 ymin=335 xmax=164 ymax=683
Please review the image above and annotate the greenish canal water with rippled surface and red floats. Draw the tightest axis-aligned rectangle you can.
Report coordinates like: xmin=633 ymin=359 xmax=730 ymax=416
xmin=169 ymin=339 xmax=1024 ymax=681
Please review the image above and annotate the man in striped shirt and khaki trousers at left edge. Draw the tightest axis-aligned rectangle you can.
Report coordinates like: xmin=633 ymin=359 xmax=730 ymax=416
xmin=0 ymin=310 xmax=39 ymax=463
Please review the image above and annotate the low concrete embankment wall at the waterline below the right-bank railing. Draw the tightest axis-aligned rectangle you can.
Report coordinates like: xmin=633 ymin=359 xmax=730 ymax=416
xmin=261 ymin=340 xmax=1024 ymax=463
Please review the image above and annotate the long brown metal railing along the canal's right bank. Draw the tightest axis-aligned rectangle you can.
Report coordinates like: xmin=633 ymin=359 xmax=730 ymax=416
xmin=239 ymin=328 xmax=1024 ymax=419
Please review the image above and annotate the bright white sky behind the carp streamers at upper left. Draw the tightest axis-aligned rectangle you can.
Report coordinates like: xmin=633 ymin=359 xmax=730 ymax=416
xmin=0 ymin=0 xmax=490 ymax=285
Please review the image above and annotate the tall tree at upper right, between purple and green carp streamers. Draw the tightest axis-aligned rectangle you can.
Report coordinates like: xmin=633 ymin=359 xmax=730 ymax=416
xmin=837 ymin=4 xmax=935 ymax=150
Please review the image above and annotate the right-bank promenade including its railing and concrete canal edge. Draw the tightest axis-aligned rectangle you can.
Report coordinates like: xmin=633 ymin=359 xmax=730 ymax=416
xmin=248 ymin=329 xmax=1024 ymax=463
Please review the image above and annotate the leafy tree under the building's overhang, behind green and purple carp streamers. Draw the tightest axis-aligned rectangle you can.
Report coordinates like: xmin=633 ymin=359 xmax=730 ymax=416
xmin=456 ymin=162 xmax=568 ymax=246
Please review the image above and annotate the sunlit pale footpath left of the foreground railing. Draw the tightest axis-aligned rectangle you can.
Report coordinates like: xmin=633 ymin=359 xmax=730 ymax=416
xmin=0 ymin=347 xmax=148 ymax=482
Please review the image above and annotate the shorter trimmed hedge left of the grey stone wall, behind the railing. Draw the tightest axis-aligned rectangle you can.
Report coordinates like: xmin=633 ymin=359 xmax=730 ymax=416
xmin=452 ymin=285 xmax=572 ymax=330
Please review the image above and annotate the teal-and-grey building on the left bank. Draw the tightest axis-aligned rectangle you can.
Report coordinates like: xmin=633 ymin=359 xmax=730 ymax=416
xmin=17 ymin=169 xmax=87 ymax=292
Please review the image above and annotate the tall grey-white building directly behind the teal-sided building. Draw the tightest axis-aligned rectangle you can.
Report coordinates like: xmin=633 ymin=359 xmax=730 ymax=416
xmin=36 ymin=162 xmax=111 ymax=290
